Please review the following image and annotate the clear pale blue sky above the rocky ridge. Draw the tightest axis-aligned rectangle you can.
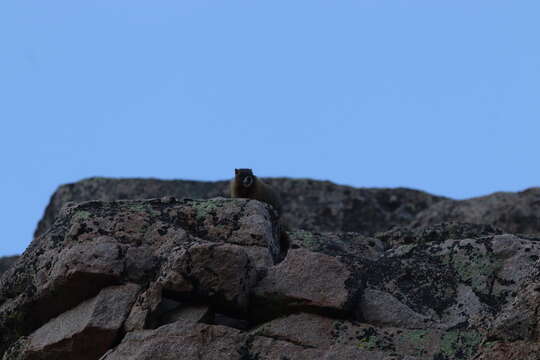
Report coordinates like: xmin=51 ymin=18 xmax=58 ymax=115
xmin=0 ymin=0 xmax=540 ymax=255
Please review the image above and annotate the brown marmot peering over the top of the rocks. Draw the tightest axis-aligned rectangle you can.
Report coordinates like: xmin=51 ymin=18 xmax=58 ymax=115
xmin=231 ymin=169 xmax=281 ymax=216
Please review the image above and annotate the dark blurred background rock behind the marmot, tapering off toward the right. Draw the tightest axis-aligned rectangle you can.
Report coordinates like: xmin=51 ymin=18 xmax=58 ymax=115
xmin=35 ymin=178 xmax=445 ymax=237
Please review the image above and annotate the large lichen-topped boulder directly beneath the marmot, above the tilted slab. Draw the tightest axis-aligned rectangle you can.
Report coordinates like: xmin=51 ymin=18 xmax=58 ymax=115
xmin=0 ymin=198 xmax=280 ymax=353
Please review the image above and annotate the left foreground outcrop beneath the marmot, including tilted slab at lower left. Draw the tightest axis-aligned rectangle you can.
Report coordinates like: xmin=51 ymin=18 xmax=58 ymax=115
xmin=0 ymin=198 xmax=288 ymax=359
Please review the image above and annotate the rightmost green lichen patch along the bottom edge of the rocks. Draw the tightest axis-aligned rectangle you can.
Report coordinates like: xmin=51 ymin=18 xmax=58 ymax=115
xmin=440 ymin=331 xmax=482 ymax=359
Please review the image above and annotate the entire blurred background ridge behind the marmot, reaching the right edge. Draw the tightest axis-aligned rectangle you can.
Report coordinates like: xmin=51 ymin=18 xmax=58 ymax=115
xmin=35 ymin=178 xmax=540 ymax=237
